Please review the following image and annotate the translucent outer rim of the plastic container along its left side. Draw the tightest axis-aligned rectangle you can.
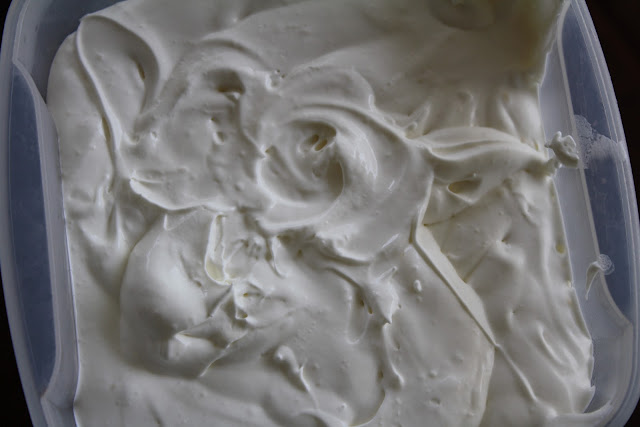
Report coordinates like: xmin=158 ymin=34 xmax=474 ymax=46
xmin=0 ymin=0 xmax=46 ymax=426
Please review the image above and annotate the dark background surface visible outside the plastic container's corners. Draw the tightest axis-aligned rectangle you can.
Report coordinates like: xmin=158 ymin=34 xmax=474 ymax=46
xmin=0 ymin=0 xmax=640 ymax=427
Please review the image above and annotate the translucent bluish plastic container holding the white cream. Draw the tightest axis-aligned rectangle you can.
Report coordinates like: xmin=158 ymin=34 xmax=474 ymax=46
xmin=0 ymin=0 xmax=640 ymax=427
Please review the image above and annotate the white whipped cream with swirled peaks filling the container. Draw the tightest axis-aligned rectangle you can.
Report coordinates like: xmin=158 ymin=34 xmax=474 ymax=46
xmin=48 ymin=0 xmax=593 ymax=426
